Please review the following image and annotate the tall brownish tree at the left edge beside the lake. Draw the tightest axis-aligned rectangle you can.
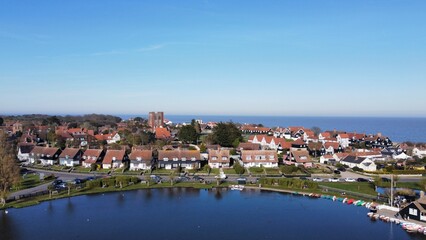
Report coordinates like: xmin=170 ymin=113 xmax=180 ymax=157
xmin=0 ymin=133 xmax=20 ymax=206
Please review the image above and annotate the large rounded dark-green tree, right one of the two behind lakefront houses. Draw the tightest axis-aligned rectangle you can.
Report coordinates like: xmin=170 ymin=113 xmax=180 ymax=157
xmin=212 ymin=122 xmax=243 ymax=147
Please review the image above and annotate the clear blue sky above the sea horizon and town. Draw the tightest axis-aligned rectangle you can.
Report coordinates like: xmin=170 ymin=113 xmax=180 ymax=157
xmin=0 ymin=0 xmax=426 ymax=117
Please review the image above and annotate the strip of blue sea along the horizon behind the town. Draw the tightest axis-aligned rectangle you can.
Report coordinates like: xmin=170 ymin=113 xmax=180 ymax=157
xmin=119 ymin=115 xmax=426 ymax=143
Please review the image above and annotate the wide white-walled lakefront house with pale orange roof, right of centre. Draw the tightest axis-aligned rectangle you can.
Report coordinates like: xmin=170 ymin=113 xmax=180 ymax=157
xmin=241 ymin=150 xmax=278 ymax=168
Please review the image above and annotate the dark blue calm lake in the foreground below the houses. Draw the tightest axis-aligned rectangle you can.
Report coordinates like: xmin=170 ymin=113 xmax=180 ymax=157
xmin=0 ymin=189 xmax=420 ymax=240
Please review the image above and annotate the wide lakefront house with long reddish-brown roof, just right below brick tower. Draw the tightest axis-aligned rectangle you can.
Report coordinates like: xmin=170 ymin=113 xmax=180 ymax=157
xmin=158 ymin=149 xmax=202 ymax=169
